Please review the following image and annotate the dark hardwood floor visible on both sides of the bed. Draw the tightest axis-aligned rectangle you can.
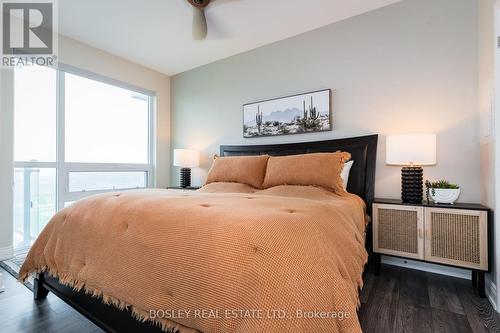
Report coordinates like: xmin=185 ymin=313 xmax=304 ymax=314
xmin=0 ymin=265 xmax=500 ymax=333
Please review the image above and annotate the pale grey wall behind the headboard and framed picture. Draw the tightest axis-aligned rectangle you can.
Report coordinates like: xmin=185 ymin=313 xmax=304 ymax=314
xmin=171 ymin=0 xmax=482 ymax=202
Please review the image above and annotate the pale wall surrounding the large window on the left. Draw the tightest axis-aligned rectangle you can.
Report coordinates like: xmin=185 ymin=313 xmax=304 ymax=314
xmin=0 ymin=36 xmax=171 ymax=260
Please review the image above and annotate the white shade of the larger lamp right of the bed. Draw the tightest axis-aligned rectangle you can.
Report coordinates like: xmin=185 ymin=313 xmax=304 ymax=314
xmin=385 ymin=133 xmax=436 ymax=166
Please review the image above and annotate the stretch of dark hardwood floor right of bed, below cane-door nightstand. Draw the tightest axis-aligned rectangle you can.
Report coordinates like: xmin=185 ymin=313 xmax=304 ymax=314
xmin=359 ymin=265 xmax=500 ymax=333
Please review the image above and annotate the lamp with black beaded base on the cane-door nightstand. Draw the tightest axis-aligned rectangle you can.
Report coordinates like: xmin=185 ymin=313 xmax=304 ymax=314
xmin=386 ymin=133 xmax=436 ymax=203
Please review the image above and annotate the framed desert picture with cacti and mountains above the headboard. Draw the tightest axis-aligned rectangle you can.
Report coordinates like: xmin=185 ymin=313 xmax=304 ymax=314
xmin=243 ymin=89 xmax=332 ymax=138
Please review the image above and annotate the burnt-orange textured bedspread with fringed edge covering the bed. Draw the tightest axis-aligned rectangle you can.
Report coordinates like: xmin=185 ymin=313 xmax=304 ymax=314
xmin=20 ymin=183 xmax=367 ymax=333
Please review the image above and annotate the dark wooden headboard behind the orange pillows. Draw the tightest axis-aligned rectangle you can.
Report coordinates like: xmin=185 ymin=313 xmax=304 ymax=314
xmin=220 ymin=135 xmax=378 ymax=212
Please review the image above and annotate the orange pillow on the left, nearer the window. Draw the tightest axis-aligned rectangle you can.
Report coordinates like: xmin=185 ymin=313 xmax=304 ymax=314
xmin=205 ymin=155 xmax=269 ymax=188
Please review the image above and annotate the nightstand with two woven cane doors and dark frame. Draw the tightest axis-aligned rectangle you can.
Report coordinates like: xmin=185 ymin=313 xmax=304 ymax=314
xmin=373 ymin=199 xmax=491 ymax=297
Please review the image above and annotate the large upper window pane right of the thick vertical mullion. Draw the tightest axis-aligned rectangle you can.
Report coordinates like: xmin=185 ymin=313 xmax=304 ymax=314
xmin=65 ymin=74 xmax=149 ymax=164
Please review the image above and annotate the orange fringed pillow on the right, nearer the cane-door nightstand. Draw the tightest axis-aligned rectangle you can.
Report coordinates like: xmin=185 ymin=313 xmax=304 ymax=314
xmin=264 ymin=152 xmax=351 ymax=194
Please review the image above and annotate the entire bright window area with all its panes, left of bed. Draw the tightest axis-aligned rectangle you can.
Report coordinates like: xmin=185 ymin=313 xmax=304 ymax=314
xmin=14 ymin=67 xmax=154 ymax=248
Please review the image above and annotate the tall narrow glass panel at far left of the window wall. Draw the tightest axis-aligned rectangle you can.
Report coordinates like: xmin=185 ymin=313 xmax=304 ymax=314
xmin=14 ymin=67 xmax=58 ymax=247
